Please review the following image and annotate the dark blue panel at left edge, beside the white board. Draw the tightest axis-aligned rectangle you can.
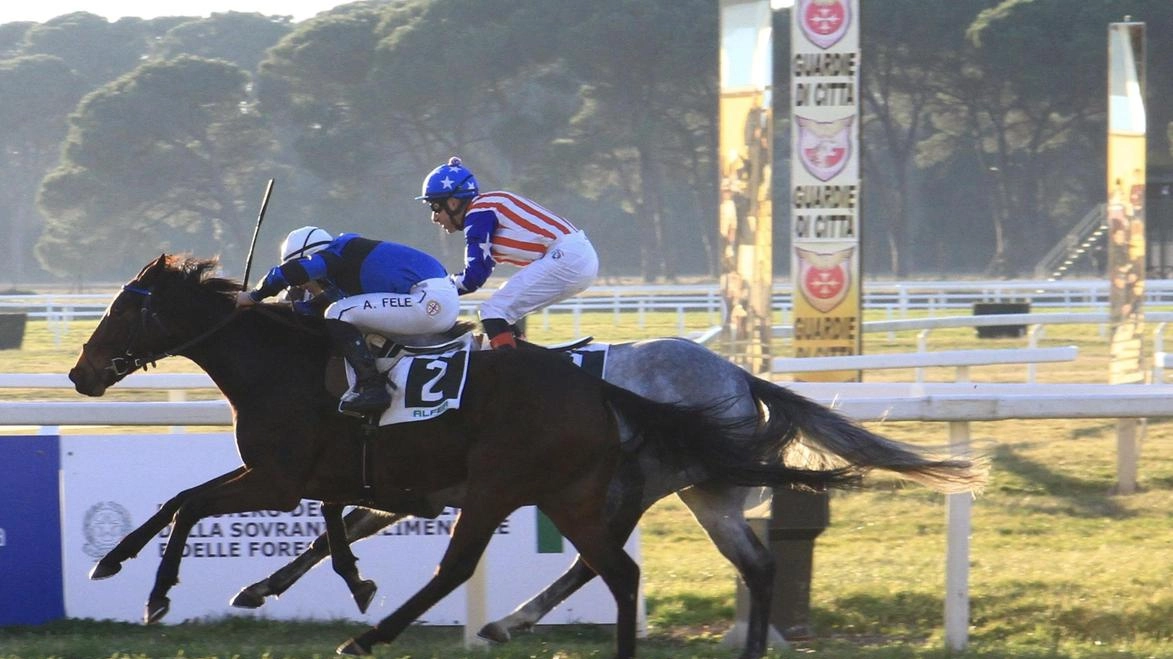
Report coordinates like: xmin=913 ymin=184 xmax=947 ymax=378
xmin=0 ymin=435 xmax=66 ymax=626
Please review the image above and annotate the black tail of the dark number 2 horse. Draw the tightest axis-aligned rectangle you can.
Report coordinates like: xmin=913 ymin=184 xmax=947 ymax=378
xmin=604 ymin=382 xmax=861 ymax=490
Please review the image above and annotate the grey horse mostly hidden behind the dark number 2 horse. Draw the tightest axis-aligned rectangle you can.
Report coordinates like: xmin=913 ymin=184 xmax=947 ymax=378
xmin=232 ymin=338 xmax=985 ymax=659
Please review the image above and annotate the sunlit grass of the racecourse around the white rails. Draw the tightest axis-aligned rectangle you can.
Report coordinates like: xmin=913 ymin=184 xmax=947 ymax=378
xmin=0 ymin=313 xmax=1173 ymax=659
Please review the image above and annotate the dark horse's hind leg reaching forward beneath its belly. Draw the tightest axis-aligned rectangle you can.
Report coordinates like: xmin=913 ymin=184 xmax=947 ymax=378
xmin=338 ymin=495 xmax=517 ymax=657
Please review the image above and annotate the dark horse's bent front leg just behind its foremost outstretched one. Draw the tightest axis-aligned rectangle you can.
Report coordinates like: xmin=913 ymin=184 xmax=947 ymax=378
xmin=143 ymin=468 xmax=300 ymax=624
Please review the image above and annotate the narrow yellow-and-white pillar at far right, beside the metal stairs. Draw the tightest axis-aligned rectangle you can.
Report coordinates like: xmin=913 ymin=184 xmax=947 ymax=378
xmin=1107 ymin=22 xmax=1146 ymax=383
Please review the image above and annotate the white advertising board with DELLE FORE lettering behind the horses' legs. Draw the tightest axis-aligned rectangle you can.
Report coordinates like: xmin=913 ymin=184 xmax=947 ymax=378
xmin=61 ymin=434 xmax=639 ymax=625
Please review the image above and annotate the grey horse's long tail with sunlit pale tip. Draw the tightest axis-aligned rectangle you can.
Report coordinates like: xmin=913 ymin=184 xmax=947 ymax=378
xmin=746 ymin=373 xmax=988 ymax=492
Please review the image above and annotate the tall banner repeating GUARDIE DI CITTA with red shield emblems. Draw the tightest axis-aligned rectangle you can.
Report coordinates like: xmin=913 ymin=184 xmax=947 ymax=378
xmin=791 ymin=0 xmax=862 ymax=382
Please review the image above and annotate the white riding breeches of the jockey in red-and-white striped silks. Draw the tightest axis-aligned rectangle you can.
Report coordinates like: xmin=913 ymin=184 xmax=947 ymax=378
xmin=480 ymin=231 xmax=598 ymax=324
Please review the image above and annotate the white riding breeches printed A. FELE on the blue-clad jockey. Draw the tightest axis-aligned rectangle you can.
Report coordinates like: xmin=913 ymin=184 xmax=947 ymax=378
xmin=326 ymin=277 xmax=460 ymax=337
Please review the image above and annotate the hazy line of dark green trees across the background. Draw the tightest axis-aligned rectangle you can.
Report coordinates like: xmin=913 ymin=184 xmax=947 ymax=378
xmin=0 ymin=0 xmax=1173 ymax=287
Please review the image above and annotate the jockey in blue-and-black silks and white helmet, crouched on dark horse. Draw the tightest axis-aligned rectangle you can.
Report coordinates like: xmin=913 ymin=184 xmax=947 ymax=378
xmin=237 ymin=226 xmax=460 ymax=414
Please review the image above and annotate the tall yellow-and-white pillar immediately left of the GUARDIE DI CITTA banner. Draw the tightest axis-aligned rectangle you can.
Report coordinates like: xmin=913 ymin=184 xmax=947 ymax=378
xmin=718 ymin=0 xmax=774 ymax=373
